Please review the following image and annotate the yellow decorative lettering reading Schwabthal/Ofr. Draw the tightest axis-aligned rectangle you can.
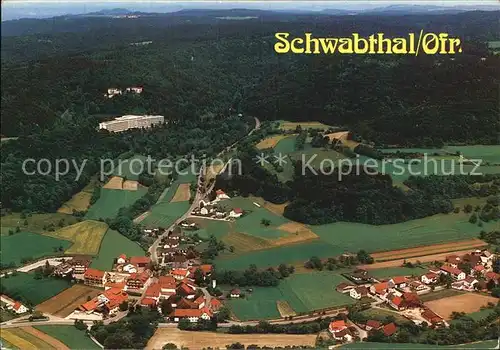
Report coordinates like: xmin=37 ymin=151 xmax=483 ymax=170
xmin=274 ymin=30 xmax=462 ymax=56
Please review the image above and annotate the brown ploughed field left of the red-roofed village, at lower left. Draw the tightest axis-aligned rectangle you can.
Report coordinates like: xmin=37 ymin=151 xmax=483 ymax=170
xmin=36 ymin=284 xmax=102 ymax=318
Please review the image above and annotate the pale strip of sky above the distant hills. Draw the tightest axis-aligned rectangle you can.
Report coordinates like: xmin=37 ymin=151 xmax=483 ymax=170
xmin=2 ymin=0 xmax=500 ymax=21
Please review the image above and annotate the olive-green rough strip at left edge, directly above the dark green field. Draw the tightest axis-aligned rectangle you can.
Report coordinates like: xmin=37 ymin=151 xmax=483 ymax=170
xmin=0 ymin=213 xmax=77 ymax=234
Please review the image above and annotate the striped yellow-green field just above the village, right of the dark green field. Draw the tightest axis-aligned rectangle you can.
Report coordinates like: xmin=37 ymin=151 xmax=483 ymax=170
xmin=46 ymin=220 xmax=108 ymax=255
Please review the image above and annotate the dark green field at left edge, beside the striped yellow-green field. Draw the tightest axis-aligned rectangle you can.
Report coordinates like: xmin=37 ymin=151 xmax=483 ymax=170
xmin=0 ymin=232 xmax=72 ymax=266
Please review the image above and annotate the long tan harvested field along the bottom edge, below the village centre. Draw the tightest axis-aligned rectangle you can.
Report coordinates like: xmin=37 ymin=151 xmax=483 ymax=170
xmin=146 ymin=327 xmax=316 ymax=350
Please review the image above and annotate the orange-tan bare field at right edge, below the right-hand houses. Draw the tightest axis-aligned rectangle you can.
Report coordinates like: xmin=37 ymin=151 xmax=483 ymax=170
xmin=424 ymin=293 xmax=498 ymax=320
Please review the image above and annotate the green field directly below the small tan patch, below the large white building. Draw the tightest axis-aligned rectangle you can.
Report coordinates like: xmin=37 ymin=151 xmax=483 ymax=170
xmin=85 ymin=187 xmax=147 ymax=220
